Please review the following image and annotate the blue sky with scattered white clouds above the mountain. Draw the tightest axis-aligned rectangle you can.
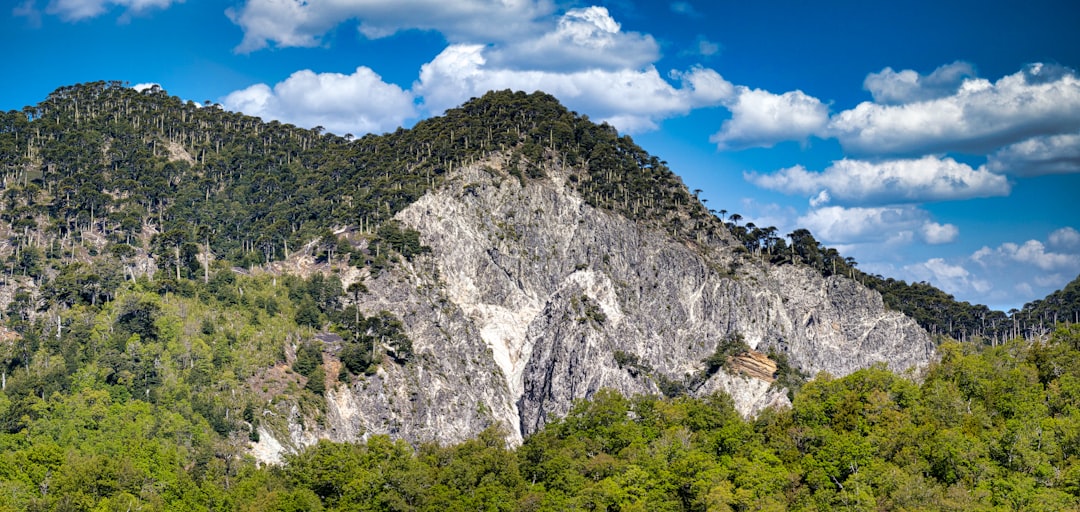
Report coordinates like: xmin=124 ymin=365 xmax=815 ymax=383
xmin=0 ymin=0 xmax=1080 ymax=310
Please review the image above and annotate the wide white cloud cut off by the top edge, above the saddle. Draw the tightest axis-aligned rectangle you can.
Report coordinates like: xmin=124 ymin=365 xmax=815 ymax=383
xmin=227 ymin=0 xmax=554 ymax=52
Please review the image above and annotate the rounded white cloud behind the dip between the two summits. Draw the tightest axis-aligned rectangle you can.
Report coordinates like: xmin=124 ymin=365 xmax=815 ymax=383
xmin=222 ymin=66 xmax=417 ymax=135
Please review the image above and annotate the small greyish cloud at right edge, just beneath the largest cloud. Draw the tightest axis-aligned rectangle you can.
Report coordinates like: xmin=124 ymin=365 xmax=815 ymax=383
xmin=986 ymin=133 xmax=1080 ymax=176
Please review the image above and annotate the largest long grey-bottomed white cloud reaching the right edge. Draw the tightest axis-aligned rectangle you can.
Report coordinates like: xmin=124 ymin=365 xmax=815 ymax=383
xmin=829 ymin=64 xmax=1080 ymax=154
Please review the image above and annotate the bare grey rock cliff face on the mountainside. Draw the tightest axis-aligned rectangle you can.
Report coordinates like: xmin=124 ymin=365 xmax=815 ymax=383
xmin=250 ymin=158 xmax=934 ymax=460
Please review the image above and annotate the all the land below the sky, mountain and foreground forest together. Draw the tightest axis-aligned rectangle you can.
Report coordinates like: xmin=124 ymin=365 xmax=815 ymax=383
xmin=0 ymin=82 xmax=1080 ymax=511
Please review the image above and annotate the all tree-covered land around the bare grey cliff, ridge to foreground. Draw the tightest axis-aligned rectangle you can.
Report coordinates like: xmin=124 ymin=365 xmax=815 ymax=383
xmin=0 ymin=82 xmax=1080 ymax=510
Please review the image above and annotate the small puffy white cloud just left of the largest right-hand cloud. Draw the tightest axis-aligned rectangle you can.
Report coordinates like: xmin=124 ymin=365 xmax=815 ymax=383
xmin=708 ymin=85 xmax=828 ymax=149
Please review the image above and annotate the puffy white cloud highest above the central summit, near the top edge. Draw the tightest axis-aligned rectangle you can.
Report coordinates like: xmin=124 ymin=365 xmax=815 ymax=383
xmin=485 ymin=6 xmax=660 ymax=71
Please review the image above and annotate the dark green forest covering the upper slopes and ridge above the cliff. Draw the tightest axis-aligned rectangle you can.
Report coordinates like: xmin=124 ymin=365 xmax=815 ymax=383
xmin=0 ymin=82 xmax=1058 ymax=339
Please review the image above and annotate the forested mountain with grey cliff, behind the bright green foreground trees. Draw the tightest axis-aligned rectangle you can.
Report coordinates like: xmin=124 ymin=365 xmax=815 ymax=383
xmin=0 ymin=82 xmax=934 ymax=461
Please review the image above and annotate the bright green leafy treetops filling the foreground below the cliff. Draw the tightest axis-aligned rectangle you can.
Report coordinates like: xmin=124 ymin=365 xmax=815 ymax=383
xmin=0 ymin=319 xmax=1080 ymax=511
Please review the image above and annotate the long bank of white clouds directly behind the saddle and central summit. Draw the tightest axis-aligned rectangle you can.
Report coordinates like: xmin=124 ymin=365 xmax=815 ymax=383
xmin=222 ymin=6 xmax=737 ymax=134
